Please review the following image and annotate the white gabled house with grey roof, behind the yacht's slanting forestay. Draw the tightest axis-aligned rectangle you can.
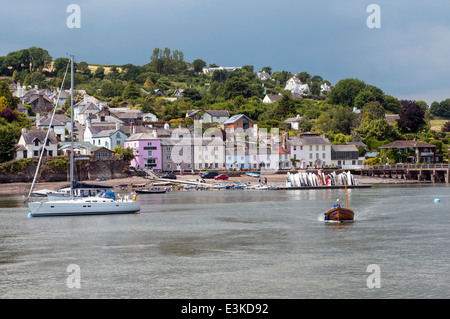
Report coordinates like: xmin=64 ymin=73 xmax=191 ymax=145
xmin=14 ymin=128 xmax=58 ymax=160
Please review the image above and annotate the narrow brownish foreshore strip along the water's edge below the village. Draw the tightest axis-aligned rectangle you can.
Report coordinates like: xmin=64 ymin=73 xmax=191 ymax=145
xmin=0 ymin=174 xmax=423 ymax=196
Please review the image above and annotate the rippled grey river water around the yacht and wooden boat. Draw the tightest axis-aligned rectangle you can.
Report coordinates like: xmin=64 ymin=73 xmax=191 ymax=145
xmin=0 ymin=184 xmax=450 ymax=299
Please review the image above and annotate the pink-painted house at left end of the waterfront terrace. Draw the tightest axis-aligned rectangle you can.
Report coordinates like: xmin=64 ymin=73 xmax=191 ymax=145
xmin=124 ymin=133 xmax=162 ymax=172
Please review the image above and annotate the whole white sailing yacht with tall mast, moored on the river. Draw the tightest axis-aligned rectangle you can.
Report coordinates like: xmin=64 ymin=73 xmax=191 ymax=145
xmin=26 ymin=55 xmax=140 ymax=217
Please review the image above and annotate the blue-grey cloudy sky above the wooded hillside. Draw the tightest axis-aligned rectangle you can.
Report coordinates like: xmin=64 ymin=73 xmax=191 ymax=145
xmin=0 ymin=0 xmax=450 ymax=105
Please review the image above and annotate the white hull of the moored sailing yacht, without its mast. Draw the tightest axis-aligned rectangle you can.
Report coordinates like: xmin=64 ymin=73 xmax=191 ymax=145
xmin=28 ymin=199 xmax=140 ymax=217
